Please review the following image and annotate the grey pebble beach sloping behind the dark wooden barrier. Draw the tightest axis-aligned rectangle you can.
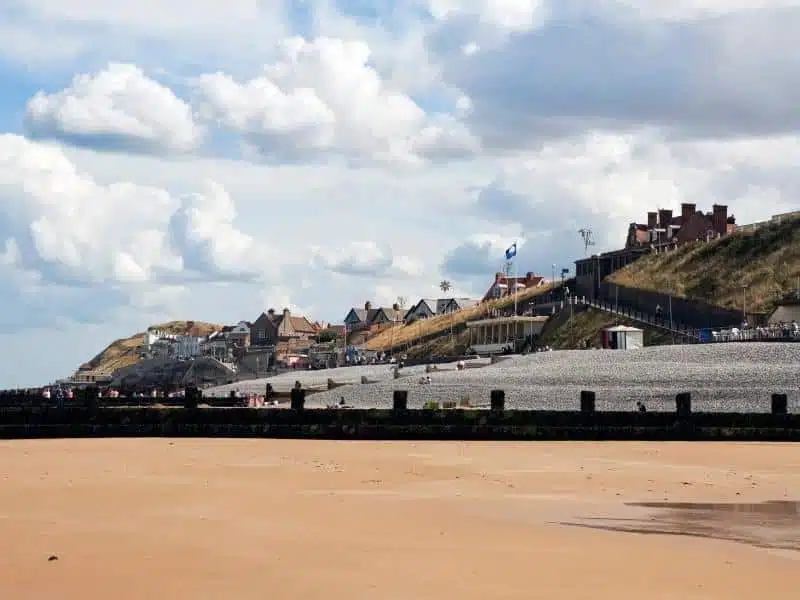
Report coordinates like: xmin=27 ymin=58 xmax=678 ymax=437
xmin=206 ymin=343 xmax=800 ymax=412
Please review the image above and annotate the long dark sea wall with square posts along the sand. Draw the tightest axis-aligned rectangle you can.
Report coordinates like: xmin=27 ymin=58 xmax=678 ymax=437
xmin=0 ymin=391 xmax=800 ymax=441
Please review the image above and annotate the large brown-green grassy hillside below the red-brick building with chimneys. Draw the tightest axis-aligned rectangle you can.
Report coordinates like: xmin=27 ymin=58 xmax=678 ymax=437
xmin=608 ymin=218 xmax=800 ymax=313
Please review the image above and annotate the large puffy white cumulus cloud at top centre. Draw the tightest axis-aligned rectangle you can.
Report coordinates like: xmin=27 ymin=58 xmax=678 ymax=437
xmin=194 ymin=37 xmax=477 ymax=162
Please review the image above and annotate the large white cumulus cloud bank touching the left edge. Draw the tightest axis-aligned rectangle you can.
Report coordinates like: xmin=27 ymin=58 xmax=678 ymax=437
xmin=0 ymin=134 xmax=270 ymax=324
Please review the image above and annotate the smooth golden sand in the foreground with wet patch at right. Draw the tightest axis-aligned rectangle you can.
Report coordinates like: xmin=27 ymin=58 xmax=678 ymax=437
xmin=0 ymin=439 xmax=800 ymax=600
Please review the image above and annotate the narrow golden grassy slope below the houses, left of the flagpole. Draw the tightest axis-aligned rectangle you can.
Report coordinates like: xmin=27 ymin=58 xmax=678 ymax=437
xmin=365 ymin=285 xmax=551 ymax=350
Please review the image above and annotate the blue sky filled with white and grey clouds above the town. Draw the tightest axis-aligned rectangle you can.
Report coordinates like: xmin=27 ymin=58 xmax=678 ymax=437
xmin=0 ymin=0 xmax=800 ymax=387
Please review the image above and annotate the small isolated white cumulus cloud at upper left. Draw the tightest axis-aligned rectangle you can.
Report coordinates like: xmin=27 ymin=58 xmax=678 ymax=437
xmin=25 ymin=63 xmax=203 ymax=152
